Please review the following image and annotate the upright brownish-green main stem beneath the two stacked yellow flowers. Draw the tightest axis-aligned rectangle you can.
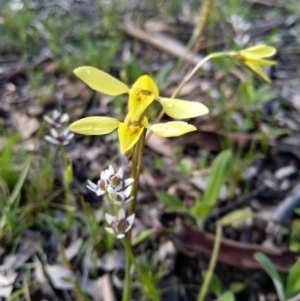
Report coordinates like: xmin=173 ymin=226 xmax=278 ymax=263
xmin=122 ymin=130 xmax=146 ymax=301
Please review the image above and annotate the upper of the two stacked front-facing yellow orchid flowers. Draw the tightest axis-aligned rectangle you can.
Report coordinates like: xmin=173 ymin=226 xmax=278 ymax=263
xmin=74 ymin=66 xmax=208 ymax=122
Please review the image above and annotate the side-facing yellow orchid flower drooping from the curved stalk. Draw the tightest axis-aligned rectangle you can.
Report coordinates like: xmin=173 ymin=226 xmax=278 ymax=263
xmin=231 ymin=45 xmax=276 ymax=83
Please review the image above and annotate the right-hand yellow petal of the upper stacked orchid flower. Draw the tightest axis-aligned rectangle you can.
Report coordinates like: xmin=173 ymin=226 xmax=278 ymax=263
xmin=159 ymin=98 xmax=208 ymax=119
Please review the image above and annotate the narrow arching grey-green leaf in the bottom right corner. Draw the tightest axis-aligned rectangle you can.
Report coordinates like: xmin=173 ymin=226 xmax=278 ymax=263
xmin=253 ymin=252 xmax=284 ymax=301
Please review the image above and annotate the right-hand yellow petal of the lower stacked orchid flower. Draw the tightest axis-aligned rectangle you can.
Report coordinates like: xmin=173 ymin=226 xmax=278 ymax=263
xmin=149 ymin=121 xmax=197 ymax=137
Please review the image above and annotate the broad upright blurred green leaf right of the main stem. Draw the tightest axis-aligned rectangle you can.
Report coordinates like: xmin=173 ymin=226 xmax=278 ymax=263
xmin=204 ymin=150 xmax=233 ymax=206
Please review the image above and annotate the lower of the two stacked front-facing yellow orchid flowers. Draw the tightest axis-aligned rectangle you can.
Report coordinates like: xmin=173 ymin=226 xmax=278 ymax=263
xmin=69 ymin=113 xmax=196 ymax=154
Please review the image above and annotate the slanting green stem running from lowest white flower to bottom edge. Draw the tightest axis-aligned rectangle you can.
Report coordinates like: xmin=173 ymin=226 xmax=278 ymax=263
xmin=121 ymin=238 xmax=159 ymax=301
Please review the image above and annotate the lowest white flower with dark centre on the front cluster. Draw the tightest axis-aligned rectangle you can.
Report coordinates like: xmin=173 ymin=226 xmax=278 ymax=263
xmin=105 ymin=208 xmax=135 ymax=239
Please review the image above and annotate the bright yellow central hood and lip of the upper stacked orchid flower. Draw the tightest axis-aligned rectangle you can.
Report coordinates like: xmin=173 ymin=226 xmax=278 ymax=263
xmin=128 ymin=75 xmax=159 ymax=121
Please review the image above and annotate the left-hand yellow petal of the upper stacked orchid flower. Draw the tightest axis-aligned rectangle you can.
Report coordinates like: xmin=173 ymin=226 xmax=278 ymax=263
xmin=74 ymin=66 xmax=129 ymax=95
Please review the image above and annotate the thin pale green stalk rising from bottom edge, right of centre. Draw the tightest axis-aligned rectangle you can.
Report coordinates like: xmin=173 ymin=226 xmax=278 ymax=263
xmin=197 ymin=224 xmax=222 ymax=301
